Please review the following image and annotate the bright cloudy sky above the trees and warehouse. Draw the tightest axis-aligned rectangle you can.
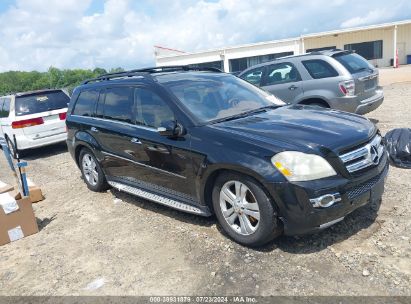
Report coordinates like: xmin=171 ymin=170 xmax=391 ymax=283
xmin=0 ymin=0 xmax=411 ymax=71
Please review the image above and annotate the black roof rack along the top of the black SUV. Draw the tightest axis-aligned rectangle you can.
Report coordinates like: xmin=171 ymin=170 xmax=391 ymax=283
xmin=82 ymin=65 xmax=222 ymax=84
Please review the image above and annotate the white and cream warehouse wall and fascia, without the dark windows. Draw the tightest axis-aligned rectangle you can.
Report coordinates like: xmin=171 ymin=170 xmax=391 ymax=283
xmin=156 ymin=21 xmax=411 ymax=72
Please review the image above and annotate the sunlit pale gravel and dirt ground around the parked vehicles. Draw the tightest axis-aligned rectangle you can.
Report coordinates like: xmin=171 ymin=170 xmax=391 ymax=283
xmin=0 ymin=82 xmax=411 ymax=295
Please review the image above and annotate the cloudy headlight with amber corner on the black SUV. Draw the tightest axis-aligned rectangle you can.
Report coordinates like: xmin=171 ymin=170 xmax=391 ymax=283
xmin=271 ymin=151 xmax=337 ymax=182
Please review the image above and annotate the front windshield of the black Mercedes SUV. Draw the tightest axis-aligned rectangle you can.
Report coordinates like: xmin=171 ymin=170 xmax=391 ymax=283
xmin=164 ymin=73 xmax=285 ymax=122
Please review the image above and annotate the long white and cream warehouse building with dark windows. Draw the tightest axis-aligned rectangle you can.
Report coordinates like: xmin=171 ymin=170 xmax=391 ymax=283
xmin=154 ymin=20 xmax=411 ymax=72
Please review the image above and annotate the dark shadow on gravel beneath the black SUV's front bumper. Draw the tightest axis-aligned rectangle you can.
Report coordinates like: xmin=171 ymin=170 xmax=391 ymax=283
xmin=256 ymin=200 xmax=381 ymax=254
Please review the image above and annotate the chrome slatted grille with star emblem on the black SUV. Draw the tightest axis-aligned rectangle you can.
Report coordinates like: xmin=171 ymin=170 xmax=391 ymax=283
xmin=340 ymin=135 xmax=384 ymax=173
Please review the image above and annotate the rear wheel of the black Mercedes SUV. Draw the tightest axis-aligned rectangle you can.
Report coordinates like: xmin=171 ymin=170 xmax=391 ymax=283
xmin=79 ymin=148 xmax=108 ymax=192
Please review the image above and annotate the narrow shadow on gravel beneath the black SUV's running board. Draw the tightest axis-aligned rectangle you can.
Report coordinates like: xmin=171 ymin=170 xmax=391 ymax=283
xmin=110 ymin=188 xmax=216 ymax=227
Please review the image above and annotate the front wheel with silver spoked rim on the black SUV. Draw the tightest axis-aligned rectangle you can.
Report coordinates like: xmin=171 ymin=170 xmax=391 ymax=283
xmin=212 ymin=173 xmax=282 ymax=247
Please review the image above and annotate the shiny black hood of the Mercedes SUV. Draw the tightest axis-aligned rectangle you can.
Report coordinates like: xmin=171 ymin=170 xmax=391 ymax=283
xmin=214 ymin=105 xmax=376 ymax=151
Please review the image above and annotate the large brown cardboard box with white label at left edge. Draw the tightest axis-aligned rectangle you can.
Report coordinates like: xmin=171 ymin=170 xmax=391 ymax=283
xmin=0 ymin=191 xmax=39 ymax=246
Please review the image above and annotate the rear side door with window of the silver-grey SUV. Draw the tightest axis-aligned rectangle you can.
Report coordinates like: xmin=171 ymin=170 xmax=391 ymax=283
xmin=261 ymin=62 xmax=304 ymax=103
